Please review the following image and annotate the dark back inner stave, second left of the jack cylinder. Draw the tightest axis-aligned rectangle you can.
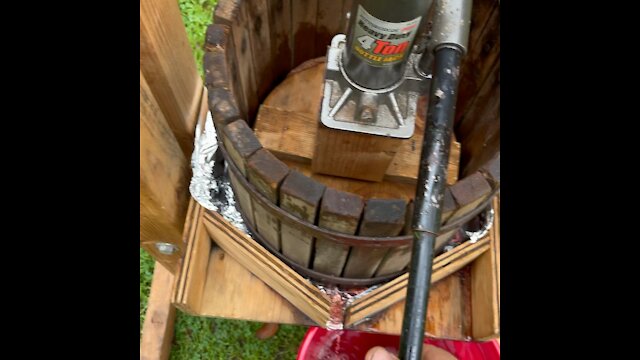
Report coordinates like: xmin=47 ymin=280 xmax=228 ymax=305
xmin=291 ymin=0 xmax=318 ymax=67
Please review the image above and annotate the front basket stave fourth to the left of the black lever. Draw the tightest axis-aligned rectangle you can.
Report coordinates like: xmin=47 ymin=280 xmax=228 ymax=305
xmin=247 ymin=149 xmax=289 ymax=251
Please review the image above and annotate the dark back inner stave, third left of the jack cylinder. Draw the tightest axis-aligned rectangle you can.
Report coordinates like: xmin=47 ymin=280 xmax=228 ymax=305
xmin=268 ymin=0 xmax=293 ymax=84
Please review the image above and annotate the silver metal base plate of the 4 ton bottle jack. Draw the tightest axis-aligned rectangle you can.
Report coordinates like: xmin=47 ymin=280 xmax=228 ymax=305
xmin=320 ymin=34 xmax=424 ymax=139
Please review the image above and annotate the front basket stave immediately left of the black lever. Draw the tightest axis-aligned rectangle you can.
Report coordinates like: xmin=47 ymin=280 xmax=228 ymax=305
xmin=343 ymin=199 xmax=407 ymax=278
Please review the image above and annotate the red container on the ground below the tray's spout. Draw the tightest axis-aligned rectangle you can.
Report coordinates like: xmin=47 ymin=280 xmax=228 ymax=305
xmin=297 ymin=327 xmax=500 ymax=360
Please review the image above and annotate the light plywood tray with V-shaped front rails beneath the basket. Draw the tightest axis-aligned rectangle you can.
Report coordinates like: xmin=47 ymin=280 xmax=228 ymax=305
xmin=172 ymin=198 xmax=500 ymax=340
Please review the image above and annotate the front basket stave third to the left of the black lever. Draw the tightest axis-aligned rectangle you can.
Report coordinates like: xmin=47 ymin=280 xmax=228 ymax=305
xmin=280 ymin=170 xmax=325 ymax=267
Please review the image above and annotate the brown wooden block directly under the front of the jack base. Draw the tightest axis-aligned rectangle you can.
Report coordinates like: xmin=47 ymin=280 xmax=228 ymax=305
xmin=311 ymin=122 xmax=402 ymax=181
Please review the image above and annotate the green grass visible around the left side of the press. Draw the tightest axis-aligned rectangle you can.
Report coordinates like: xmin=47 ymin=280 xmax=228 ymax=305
xmin=140 ymin=0 xmax=307 ymax=359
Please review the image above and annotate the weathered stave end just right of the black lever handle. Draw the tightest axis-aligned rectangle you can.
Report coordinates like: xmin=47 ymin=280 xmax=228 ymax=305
xmin=449 ymin=173 xmax=492 ymax=222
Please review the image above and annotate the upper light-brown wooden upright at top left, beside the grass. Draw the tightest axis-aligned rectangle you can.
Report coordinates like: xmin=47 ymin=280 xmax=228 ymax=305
xmin=140 ymin=0 xmax=202 ymax=157
